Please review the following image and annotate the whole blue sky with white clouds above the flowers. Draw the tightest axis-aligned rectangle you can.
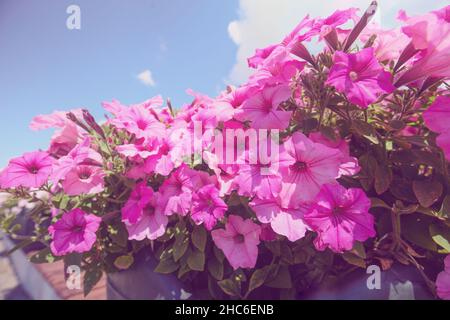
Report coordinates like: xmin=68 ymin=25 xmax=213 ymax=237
xmin=0 ymin=0 xmax=448 ymax=168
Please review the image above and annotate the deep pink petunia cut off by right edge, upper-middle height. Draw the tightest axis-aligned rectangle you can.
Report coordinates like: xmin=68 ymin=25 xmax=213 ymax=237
xmin=423 ymin=96 xmax=450 ymax=161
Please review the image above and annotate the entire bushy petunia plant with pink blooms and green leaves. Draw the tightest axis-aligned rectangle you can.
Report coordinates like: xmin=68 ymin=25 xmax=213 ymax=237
xmin=0 ymin=2 xmax=450 ymax=299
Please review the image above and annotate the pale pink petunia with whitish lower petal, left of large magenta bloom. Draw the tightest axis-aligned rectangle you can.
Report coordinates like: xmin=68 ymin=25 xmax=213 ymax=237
xmin=249 ymin=197 xmax=309 ymax=242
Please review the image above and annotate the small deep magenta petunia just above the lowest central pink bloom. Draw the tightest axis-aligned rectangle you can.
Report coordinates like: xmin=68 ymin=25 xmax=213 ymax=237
xmin=191 ymin=184 xmax=228 ymax=230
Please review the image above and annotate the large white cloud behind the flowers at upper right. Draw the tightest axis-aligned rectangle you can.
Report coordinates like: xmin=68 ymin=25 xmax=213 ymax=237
xmin=228 ymin=0 xmax=448 ymax=83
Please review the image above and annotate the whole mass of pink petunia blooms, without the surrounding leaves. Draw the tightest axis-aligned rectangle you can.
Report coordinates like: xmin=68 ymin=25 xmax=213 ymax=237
xmin=0 ymin=3 xmax=450 ymax=282
